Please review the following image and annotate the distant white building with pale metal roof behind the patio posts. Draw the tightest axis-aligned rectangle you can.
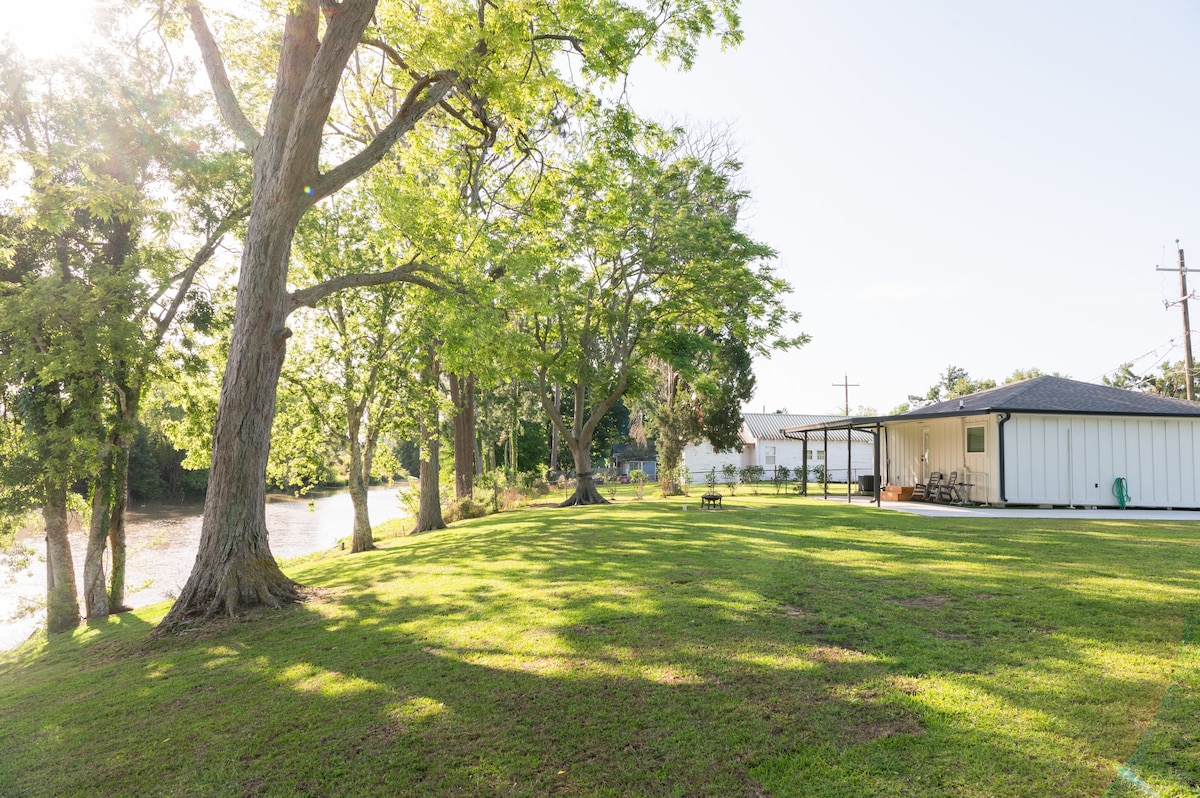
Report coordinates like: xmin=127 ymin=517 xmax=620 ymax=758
xmin=683 ymin=413 xmax=874 ymax=482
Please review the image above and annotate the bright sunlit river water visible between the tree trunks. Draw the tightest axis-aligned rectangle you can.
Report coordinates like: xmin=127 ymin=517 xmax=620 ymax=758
xmin=0 ymin=486 xmax=404 ymax=650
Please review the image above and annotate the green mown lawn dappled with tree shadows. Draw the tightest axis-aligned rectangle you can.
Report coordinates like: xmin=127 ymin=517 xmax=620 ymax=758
xmin=0 ymin=488 xmax=1200 ymax=798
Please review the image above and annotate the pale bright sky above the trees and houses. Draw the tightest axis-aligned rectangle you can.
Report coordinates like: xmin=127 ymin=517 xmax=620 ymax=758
xmin=2 ymin=0 xmax=1200 ymax=414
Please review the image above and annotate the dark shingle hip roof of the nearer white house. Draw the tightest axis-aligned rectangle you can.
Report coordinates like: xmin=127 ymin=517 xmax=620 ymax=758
xmin=894 ymin=377 xmax=1200 ymax=420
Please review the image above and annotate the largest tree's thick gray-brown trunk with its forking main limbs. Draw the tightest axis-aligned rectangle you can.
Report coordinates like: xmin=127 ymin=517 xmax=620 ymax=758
xmin=160 ymin=0 xmax=457 ymax=631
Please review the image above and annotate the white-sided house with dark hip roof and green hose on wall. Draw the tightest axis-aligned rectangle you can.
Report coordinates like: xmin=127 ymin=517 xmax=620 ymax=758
xmin=787 ymin=377 xmax=1200 ymax=508
